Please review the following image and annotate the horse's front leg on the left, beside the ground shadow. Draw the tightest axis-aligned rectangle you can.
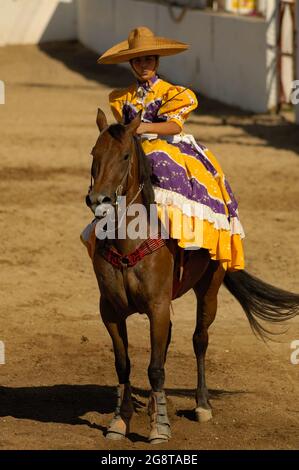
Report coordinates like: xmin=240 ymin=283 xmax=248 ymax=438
xmin=100 ymin=297 xmax=134 ymax=440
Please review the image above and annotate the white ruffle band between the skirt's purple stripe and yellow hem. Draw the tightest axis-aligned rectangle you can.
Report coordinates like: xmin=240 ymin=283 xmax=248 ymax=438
xmin=154 ymin=186 xmax=245 ymax=238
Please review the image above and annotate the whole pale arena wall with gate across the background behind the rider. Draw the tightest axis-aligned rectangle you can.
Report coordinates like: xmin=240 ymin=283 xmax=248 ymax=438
xmin=0 ymin=0 xmax=299 ymax=121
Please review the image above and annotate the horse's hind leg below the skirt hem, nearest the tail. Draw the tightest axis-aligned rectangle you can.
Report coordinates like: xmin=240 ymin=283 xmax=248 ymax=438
xmin=193 ymin=261 xmax=225 ymax=422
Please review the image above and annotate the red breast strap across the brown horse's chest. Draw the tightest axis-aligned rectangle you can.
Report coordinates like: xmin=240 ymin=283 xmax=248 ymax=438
xmin=101 ymin=236 xmax=165 ymax=269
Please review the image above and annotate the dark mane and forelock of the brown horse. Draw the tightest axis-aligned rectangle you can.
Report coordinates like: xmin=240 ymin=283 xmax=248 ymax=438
xmin=107 ymin=124 xmax=155 ymax=211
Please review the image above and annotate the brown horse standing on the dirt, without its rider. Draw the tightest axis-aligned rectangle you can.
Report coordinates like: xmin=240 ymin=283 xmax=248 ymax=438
xmin=86 ymin=110 xmax=299 ymax=443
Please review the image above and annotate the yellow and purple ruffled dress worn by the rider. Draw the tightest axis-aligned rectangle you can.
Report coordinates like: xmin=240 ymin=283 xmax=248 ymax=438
xmin=109 ymin=76 xmax=244 ymax=270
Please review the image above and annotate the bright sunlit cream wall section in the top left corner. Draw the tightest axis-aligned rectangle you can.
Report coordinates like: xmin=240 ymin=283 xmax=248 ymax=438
xmin=0 ymin=0 xmax=77 ymax=46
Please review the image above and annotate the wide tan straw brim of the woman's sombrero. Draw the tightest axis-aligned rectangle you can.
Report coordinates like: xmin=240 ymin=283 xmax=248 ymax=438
xmin=97 ymin=38 xmax=189 ymax=64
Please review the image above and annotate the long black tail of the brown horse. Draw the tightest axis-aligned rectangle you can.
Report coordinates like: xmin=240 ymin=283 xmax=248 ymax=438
xmin=224 ymin=270 xmax=299 ymax=339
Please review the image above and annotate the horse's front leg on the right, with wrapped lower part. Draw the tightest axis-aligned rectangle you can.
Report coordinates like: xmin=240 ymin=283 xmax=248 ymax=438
xmin=148 ymin=304 xmax=171 ymax=444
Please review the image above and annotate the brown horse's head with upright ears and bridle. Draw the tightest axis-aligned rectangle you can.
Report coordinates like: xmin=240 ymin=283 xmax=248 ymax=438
xmin=86 ymin=109 xmax=141 ymax=212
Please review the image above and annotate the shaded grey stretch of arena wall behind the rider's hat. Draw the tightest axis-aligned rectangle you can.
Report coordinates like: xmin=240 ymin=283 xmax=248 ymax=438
xmin=78 ymin=0 xmax=276 ymax=112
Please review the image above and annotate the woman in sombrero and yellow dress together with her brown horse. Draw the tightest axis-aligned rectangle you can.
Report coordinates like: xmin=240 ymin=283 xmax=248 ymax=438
xmin=83 ymin=27 xmax=299 ymax=443
